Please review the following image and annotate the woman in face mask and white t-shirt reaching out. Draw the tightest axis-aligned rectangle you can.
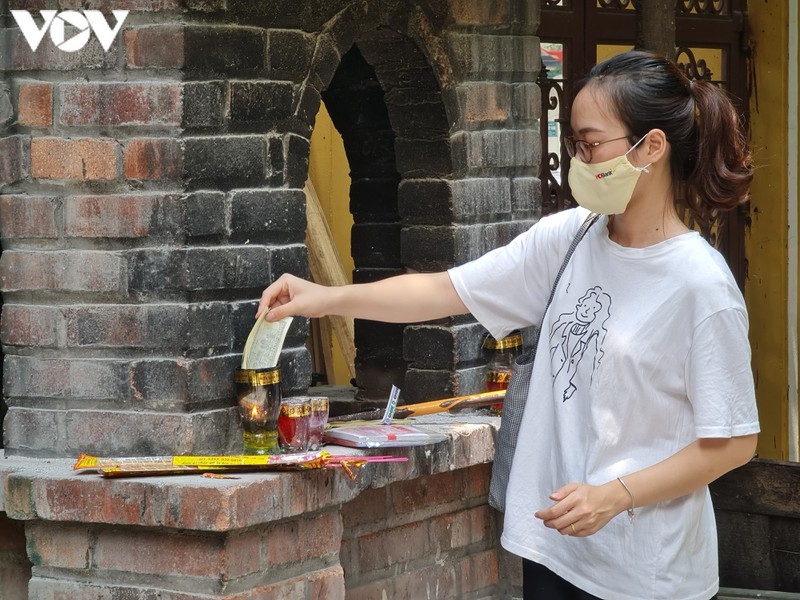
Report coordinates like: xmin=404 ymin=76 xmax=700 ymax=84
xmin=259 ymin=51 xmax=759 ymax=600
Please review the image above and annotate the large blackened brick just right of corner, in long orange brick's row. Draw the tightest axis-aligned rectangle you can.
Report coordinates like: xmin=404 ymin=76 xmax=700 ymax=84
xmin=184 ymin=136 xmax=266 ymax=189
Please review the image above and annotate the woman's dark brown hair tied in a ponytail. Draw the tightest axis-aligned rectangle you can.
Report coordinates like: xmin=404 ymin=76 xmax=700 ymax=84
xmin=584 ymin=50 xmax=753 ymax=222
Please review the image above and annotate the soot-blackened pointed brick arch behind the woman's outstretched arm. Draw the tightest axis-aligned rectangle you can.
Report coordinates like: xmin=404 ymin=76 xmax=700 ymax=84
xmin=290 ymin=5 xmax=462 ymax=399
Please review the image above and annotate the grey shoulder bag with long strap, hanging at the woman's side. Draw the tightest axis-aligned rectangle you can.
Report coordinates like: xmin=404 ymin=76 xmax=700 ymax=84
xmin=489 ymin=213 xmax=600 ymax=511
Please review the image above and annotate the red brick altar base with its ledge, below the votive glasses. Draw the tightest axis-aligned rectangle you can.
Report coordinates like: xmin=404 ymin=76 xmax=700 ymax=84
xmin=0 ymin=415 xmax=515 ymax=600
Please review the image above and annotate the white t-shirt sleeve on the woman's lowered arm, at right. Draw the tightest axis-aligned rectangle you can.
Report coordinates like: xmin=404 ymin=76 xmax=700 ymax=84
xmin=686 ymin=308 xmax=759 ymax=438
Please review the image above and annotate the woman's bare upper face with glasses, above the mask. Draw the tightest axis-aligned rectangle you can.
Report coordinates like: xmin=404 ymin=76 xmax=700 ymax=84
xmin=570 ymin=84 xmax=631 ymax=163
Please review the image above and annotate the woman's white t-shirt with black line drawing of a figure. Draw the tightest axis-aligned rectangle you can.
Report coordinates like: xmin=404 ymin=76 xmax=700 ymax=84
xmin=449 ymin=209 xmax=759 ymax=600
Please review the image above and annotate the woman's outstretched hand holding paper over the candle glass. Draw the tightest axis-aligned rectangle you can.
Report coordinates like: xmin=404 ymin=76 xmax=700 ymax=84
xmin=256 ymin=273 xmax=331 ymax=321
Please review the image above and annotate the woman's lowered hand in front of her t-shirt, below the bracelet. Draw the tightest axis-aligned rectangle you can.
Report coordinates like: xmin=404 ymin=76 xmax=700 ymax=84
xmin=534 ymin=481 xmax=627 ymax=537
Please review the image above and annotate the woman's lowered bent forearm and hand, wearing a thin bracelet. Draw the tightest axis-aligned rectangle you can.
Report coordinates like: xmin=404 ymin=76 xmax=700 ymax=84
xmin=535 ymin=434 xmax=758 ymax=536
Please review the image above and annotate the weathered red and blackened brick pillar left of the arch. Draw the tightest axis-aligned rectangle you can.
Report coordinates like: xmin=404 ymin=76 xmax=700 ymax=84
xmin=0 ymin=0 xmax=312 ymax=456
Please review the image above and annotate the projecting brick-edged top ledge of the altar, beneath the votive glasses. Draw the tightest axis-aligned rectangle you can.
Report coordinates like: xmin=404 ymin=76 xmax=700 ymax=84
xmin=0 ymin=417 xmax=499 ymax=531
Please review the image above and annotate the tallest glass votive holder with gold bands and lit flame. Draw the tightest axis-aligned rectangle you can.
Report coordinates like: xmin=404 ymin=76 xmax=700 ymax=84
xmin=236 ymin=367 xmax=281 ymax=454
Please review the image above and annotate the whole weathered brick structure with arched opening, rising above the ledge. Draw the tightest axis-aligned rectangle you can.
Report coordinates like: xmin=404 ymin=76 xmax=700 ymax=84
xmin=0 ymin=0 xmax=539 ymax=456
